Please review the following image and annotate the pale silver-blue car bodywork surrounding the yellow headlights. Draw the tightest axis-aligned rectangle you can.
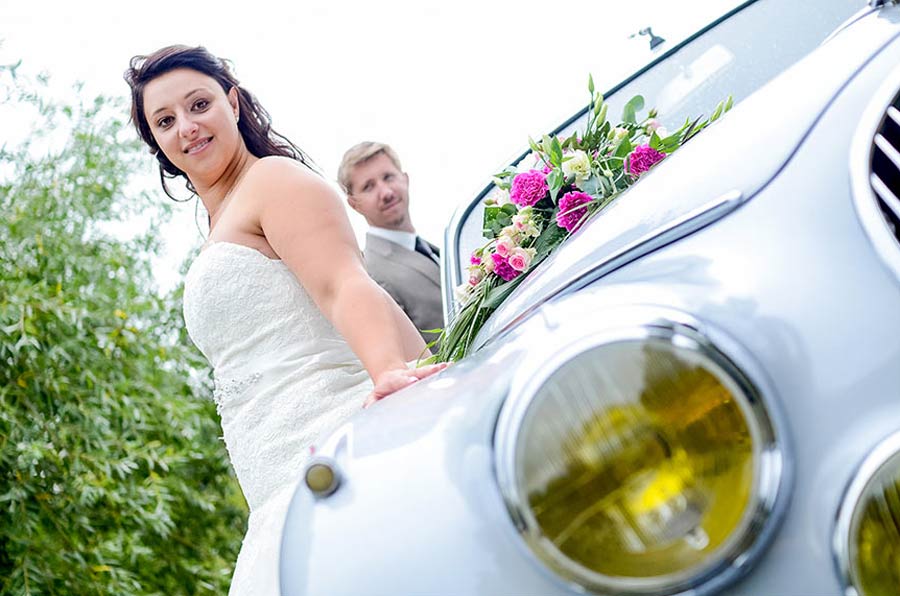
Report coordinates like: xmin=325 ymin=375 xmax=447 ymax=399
xmin=281 ymin=2 xmax=900 ymax=596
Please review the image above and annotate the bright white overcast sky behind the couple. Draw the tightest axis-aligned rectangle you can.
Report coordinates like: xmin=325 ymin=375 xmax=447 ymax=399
xmin=0 ymin=0 xmax=734 ymax=287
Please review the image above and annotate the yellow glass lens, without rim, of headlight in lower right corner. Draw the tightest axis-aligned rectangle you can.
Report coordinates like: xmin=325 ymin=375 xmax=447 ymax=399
xmin=849 ymin=440 xmax=900 ymax=596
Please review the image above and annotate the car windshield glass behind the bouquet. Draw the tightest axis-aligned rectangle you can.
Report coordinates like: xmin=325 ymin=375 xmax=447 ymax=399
xmin=444 ymin=0 xmax=862 ymax=304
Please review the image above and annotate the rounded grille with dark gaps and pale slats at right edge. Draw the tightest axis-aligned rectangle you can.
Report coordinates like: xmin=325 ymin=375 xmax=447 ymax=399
xmin=850 ymin=68 xmax=900 ymax=281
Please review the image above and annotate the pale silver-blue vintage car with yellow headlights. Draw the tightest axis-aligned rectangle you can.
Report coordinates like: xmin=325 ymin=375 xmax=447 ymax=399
xmin=280 ymin=0 xmax=900 ymax=596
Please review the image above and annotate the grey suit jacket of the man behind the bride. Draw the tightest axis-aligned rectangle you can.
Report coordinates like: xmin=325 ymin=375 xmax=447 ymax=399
xmin=363 ymin=234 xmax=444 ymax=343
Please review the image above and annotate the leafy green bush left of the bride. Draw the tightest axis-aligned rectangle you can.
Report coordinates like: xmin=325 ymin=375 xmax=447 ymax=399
xmin=0 ymin=67 xmax=246 ymax=596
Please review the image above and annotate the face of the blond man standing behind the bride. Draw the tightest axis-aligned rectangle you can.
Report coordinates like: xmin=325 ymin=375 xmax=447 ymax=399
xmin=347 ymin=153 xmax=412 ymax=231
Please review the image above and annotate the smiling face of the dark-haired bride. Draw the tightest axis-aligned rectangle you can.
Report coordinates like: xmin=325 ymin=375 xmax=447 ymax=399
xmin=144 ymin=68 xmax=242 ymax=185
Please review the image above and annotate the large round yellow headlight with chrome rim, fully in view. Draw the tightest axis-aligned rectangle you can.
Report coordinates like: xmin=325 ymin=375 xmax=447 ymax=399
xmin=497 ymin=312 xmax=787 ymax=595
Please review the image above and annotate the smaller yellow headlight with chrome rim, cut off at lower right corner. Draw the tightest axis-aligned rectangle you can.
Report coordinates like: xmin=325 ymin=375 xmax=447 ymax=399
xmin=834 ymin=432 xmax=900 ymax=596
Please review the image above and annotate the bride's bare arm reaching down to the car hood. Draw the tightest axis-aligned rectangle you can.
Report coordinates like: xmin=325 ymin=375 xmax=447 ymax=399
xmin=245 ymin=158 xmax=442 ymax=399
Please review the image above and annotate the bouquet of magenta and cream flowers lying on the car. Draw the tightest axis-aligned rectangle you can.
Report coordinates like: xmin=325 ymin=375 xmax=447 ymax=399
xmin=436 ymin=78 xmax=732 ymax=361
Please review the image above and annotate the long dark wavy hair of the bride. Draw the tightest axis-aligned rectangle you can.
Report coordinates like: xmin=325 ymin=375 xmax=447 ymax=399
xmin=125 ymin=45 xmax=316 ymax=200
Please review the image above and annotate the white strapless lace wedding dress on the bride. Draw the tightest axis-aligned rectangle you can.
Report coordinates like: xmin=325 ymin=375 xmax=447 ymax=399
xmin=184 ymin=242 xmax=372 ymax=596
